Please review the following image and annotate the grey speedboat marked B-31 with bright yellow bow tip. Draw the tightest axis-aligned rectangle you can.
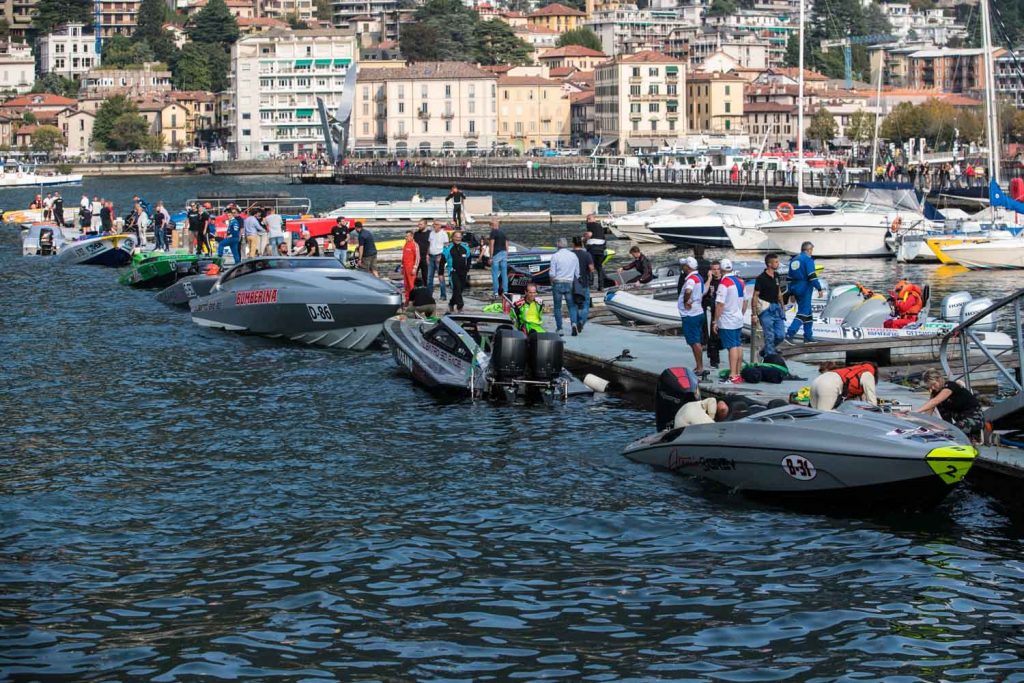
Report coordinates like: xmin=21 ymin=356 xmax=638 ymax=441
xmin=623 ymin=401 xmax=977 ymax=511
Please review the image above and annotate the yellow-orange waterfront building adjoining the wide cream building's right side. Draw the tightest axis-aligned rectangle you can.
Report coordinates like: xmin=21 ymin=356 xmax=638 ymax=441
xmin=497 ymin=76 xmax=571 ymax=152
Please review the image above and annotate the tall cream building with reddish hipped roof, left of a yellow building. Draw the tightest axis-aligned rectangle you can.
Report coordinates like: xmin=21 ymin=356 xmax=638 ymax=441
xmin=594 ymin=50 xmax=684 ymax=154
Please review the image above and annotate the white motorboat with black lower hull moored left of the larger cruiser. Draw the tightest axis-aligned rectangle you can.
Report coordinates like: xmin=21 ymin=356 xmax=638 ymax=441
xmin=647 ymin=205 xmax=775 ymax=251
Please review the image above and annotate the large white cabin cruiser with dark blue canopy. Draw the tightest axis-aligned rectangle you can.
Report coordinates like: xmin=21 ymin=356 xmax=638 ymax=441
xmin=760 ymin=182 xmax=933 ymax=258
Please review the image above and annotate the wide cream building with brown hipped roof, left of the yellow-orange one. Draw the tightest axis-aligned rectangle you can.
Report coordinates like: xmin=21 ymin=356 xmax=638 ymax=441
xmin=352 ymin=61 xmax=498 ymax=156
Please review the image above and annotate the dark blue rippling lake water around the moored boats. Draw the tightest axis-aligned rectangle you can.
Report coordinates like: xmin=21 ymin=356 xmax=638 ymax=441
xmin=0 ymin=180 xmax=1024 ymax=682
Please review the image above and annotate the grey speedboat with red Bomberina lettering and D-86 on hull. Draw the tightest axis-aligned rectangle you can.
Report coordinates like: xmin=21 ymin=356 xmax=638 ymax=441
xmin=188 ymin=256 xmax=401 ymax=350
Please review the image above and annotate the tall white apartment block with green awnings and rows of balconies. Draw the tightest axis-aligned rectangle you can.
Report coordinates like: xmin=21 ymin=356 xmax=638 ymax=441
xmin=228 ymin=29 xmax=357 ymax=159
